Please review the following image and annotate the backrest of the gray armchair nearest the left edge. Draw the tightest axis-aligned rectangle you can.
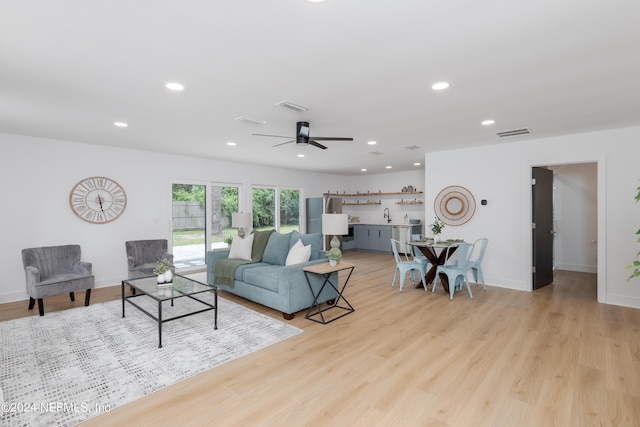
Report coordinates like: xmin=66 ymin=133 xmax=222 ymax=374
xmin=22 ymin=245 xmax=81 ymax=280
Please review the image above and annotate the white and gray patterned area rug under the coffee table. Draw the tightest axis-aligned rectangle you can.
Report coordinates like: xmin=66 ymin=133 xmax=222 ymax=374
xmin=0 ymin=293 xmax=302 ymax=426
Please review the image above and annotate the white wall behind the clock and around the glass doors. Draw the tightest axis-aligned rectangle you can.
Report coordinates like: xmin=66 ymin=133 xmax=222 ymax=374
xmin=0 ymin=134 xmax=344 ymax=302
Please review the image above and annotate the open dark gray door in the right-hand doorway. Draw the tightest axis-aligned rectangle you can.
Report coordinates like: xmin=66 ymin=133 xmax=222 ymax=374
xmin=531 ymin=168 xmax=554 ymax=289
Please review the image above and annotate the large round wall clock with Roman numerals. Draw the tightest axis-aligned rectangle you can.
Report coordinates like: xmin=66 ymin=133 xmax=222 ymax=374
xmin=69 ymin=176 xmax=127 ymax=224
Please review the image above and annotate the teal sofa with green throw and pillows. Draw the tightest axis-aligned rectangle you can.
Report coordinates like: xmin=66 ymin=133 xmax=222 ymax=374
xmin=206 ymin=231 xmax=338 ymax=320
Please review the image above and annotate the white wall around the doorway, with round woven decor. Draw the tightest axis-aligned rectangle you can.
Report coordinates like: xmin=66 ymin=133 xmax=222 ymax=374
xmin=425 ymin=127 xmax=640 ymax=308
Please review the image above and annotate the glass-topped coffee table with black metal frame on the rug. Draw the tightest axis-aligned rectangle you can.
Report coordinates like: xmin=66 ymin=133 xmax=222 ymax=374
xmin=122 ymin=274 xmax=218 ymax=348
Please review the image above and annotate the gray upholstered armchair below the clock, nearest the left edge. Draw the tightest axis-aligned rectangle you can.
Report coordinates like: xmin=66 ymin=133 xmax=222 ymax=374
xmin=22 ymin=245 xmax=95 ymax=316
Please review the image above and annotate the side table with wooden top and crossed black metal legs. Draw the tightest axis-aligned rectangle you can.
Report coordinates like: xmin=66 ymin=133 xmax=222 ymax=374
xmin=302 ymin=262 xmax=355 ymax=325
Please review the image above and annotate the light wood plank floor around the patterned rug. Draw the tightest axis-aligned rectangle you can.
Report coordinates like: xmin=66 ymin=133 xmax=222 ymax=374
xmin=0 ymin=252 xmax=640 ymax=427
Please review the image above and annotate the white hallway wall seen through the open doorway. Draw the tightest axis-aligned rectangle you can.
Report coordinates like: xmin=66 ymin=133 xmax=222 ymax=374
xmin=552 ymin=163 xmax=598 ymax=273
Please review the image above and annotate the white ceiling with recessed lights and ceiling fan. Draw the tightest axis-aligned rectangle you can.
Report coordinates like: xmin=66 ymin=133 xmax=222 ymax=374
xmin=0 ymin=0 xmax=640 ymax=175
